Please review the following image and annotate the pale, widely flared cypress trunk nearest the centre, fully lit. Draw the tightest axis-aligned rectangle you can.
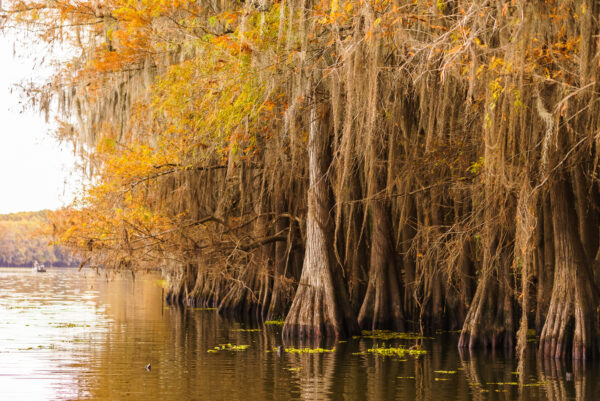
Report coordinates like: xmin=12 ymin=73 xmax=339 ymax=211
xmin=283 ymin=93 xmax=359 ymax=338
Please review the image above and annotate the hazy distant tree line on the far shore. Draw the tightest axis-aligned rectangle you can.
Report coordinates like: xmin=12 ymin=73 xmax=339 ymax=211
xmin=0 ymin=210 xmax=79 ymax=267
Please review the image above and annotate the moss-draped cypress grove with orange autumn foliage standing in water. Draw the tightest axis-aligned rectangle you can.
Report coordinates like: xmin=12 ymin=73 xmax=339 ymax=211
xmin=2 ymin=0 xmax=600 ymax=359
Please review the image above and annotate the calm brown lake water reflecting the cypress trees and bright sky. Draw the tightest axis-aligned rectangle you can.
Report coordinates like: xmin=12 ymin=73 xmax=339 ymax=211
xmin=0 ymin=268 xmax=600 ymax=401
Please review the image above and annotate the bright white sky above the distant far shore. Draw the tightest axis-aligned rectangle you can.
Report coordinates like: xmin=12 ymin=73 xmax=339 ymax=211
xmin=0 ymin=34 xmax=78 ymax=214
